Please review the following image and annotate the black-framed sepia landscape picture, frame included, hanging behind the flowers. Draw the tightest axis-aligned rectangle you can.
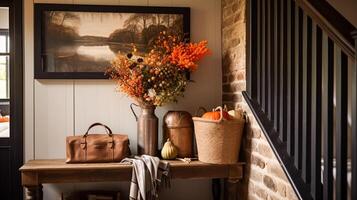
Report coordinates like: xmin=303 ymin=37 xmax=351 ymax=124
xmin=35 ymin=4 xmax=190 ymax=79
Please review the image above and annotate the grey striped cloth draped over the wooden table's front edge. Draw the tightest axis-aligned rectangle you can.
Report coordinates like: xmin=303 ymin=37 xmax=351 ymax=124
xmin=122 ymin=155 xmax=170 ymax=200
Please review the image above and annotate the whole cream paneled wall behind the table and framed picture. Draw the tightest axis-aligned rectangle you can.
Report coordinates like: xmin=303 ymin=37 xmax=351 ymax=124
xmin=24 ymin=0 xmax=221 ymax=200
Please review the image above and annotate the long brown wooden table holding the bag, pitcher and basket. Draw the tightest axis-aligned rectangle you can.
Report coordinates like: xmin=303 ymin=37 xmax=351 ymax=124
xmin=20 ymin=160 xmax=243 ymax=200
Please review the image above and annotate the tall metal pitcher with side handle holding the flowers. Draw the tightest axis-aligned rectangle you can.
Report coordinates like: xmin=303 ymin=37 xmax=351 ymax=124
xmin=130 ymin=103 xmax=159 ymax=156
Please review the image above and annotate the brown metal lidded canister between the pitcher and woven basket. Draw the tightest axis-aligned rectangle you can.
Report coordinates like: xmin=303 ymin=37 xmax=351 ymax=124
xmin=163 ymin=111 xmax=193 ymax=158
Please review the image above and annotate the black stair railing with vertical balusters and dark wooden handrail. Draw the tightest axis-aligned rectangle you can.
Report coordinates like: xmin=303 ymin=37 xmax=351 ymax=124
xmin=243 ymin=0 xmax=357 ymax=200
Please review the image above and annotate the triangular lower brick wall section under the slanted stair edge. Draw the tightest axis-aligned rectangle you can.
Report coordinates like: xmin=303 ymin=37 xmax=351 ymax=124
xmin=238 ymin=99 xmax=298 ymax=200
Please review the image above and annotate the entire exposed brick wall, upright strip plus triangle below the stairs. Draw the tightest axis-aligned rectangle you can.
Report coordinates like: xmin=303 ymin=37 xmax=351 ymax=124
xmin=222 ymin=0 xmax=298 ymax=200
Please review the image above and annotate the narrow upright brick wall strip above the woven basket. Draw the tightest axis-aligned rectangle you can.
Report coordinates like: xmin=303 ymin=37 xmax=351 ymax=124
xmin=222 ymin=0 xmax=246 ymax=107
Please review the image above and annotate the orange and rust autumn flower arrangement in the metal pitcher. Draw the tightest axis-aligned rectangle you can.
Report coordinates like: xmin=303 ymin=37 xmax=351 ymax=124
xmin=107 ymin=32 xmax=210 ymax=106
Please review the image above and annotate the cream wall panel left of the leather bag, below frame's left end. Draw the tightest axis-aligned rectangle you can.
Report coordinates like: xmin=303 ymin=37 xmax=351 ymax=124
xmin=34 ymin=80 xmax=74 ymax=159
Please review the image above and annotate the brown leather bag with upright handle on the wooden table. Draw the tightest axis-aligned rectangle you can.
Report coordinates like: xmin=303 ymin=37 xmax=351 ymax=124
xmin=66 ymin=123 xmax=130 ymax=163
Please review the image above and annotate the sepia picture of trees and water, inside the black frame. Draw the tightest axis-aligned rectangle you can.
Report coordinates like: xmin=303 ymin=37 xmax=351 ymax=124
xmin=42 ymin=6 xmax=183 ymax=75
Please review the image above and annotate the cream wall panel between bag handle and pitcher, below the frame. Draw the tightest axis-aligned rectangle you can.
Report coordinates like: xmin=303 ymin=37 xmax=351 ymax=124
xmin=74 ymin=80 xmax=136 ymax=150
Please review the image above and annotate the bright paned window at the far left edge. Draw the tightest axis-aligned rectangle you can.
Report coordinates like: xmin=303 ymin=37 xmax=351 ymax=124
xmin=0 ymin=29 xmax=10 ymax=99
